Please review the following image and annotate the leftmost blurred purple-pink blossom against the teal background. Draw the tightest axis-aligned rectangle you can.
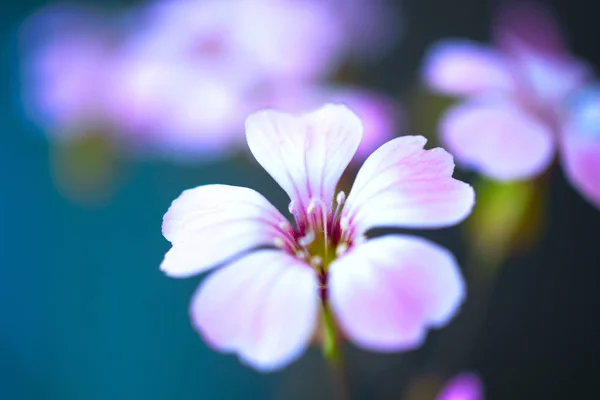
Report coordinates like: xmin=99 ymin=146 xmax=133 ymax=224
xmin=21 ymin=6 xmax=111 ymax=135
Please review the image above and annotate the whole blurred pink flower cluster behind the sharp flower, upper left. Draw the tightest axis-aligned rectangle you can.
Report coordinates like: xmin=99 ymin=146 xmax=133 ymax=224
xmin=21 ymin=0 xmax=401 ymax=160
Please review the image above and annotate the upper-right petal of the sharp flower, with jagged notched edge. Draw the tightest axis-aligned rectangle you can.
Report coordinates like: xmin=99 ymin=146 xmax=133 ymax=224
xmin=342 ymin=136 xmax=474 ymax=233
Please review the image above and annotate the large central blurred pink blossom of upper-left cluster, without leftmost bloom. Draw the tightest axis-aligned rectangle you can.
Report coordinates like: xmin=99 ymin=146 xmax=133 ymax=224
xmin=105 ymin=0 xmax=341 ymax=156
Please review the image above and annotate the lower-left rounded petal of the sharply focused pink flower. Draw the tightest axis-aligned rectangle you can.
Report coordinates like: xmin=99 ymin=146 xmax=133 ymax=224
xmin=190 ymin=250 xmax=319 ymax=371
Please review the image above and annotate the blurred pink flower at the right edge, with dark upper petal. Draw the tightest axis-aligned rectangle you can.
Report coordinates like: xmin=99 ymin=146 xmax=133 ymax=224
xmin=423 ymin=3 xmax=600 ymax=209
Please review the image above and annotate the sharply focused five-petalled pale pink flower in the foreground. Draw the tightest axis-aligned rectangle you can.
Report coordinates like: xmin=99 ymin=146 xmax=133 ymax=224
xmin=160 ymin=104 xmax=474 ymax=371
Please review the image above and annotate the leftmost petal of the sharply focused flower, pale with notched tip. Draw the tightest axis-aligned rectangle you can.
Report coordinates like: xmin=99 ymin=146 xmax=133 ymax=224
xmin=160 ymin=185 xmax=288 ymax=277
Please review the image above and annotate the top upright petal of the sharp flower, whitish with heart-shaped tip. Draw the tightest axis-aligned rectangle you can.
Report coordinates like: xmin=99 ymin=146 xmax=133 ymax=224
xmin=246 ymin=104 xmax=363 ymax=209
